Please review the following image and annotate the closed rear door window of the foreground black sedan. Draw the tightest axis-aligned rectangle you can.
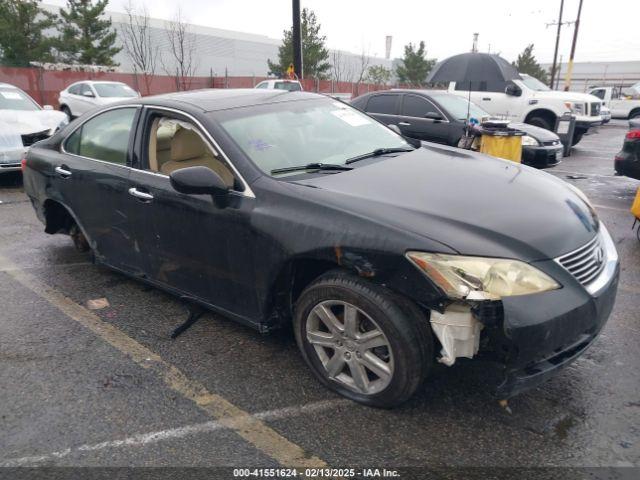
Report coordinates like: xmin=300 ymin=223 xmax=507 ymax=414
xmin=64 ymin=108 xmax=136 ymax=165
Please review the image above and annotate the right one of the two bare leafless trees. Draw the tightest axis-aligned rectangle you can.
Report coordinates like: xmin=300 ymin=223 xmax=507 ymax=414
xmin=161 ymin=8 xmax=197 ymax=90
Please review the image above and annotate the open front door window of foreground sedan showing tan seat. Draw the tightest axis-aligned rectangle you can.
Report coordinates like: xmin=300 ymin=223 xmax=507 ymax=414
xmin=147 ymin=116 xmax=235 ymax=188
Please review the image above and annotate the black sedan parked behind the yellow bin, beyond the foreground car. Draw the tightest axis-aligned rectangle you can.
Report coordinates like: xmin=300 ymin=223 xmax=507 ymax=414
xmin=351 ymin=90 xmax=563 ymax=168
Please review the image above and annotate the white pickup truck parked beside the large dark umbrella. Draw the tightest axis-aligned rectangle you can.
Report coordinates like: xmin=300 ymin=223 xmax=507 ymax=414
xmin=449 ymin=74 xmax=602 ymax=145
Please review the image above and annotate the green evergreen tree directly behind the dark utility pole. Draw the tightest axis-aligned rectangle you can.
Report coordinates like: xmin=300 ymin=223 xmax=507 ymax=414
xmin=267 ymin=8 xmax=331 ymax=79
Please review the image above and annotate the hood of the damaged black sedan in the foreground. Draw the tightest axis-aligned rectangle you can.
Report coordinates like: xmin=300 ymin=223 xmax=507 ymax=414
xmin=294 ymin=145 xmax=598 ymax=261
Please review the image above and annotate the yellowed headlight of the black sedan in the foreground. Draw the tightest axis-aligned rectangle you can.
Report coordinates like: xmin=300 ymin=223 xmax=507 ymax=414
xmin=406 ymin=252 xmax=560 ymax=300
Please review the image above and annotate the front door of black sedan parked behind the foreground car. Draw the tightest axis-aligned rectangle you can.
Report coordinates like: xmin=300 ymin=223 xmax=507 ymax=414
xmin=398 ymin=93 xmax=452 ymax=144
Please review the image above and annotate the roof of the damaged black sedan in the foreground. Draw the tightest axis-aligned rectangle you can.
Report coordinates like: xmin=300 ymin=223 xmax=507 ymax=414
xmin=135 ymin=88 xmax=326 ymax=112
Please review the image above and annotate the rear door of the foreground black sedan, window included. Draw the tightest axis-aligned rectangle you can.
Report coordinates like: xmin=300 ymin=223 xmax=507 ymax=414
xmin=56 ymin=106 xmax=141 ymax=274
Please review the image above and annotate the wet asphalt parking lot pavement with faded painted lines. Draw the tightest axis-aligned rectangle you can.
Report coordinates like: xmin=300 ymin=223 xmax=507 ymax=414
xmin=0 ymin=121 xmax=640 ymax=478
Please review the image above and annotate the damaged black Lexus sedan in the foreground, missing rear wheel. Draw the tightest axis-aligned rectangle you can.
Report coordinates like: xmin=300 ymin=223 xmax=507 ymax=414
xmin=24 ymin=89 xmax=619 ymax=407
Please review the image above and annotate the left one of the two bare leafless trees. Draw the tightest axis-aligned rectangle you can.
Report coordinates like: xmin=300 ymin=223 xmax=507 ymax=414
xmin=121 ymin=2 xmax=158 ymax=94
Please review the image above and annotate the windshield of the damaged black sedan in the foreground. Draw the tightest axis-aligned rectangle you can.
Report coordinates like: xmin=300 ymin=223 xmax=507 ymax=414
xmin=217 ymin=99 xmax=411 ymax=174
